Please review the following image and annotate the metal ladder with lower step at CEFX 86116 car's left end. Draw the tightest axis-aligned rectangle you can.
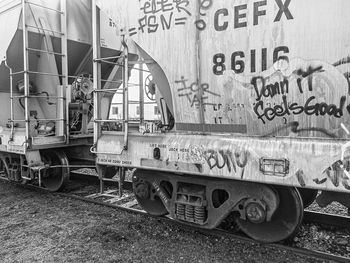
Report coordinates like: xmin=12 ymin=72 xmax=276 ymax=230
xmin=91 ymin=0 xmax=152 ymax=197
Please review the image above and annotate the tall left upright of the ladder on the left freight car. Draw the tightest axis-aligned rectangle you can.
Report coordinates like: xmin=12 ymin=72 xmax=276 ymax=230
xmin=22 ymin=0 xmax=30 ymax=147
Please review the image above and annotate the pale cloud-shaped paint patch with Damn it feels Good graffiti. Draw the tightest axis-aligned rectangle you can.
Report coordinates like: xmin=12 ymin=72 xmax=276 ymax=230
xmin=213 ymin=57 xmax=350 ymax=138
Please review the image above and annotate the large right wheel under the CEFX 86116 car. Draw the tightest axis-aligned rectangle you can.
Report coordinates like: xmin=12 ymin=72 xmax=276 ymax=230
xmin=236 ymin=186 xmax=304 ymax=243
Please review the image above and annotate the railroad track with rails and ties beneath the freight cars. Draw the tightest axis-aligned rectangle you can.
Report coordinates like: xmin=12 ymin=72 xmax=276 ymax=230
xmin=0 ymin=177 xmax=350 ymax=263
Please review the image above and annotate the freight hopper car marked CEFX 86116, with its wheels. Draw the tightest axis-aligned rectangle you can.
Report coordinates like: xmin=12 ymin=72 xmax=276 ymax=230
xmin=91 ymin=0 xmax=350 ymax=242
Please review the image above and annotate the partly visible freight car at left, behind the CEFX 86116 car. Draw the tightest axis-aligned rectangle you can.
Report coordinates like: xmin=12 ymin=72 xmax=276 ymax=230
xmin=0 ymin=0 xmax=124 ymax=191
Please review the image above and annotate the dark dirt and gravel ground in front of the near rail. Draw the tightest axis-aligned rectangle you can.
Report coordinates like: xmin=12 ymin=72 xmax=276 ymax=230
xmin=0 ymin=182 xmax=326 ymax=263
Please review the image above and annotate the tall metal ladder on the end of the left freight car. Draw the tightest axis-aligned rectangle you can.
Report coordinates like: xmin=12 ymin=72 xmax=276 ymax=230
xmin=9 ymin=0 xmax=69 ymax=147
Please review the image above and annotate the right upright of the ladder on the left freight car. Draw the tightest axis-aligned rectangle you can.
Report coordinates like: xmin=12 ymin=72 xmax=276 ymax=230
xmin=59 ymin=0 xmax=69 ymax=144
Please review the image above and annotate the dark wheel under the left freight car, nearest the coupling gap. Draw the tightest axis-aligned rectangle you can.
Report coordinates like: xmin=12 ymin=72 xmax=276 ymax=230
xmin=41 ymin=150 xmax=69 ymax=192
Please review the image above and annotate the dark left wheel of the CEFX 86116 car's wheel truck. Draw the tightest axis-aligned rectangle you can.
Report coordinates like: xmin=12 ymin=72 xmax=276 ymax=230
xmin=133 ymin=175 xmax=168 ymax=216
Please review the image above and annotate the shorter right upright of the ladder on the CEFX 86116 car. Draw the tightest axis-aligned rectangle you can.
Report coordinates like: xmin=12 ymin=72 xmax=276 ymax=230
xmin=122 ymin=36 xmax=129 ymax=150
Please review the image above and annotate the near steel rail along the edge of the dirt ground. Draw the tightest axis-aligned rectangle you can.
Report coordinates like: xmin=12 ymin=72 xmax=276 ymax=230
xmin=0 ymin=176 xmax=350 ymax=263
